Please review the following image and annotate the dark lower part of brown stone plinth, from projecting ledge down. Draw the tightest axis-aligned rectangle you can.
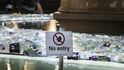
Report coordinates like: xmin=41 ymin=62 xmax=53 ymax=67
xmin=55 ymin=13 xmax=124 ymax=35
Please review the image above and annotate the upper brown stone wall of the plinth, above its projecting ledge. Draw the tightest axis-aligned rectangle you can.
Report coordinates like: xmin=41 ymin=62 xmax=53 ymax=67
xmin=59 ymin=0 xmax=124 ymax=12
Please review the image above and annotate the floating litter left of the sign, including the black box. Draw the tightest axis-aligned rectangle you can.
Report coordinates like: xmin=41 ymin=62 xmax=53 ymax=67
xmin=0 ymin=27 xmax=45 ymax=56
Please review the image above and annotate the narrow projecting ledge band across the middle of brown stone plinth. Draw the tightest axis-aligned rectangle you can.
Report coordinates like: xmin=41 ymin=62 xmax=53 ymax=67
xmin=54 ymin=13 xmax=124 ymax=21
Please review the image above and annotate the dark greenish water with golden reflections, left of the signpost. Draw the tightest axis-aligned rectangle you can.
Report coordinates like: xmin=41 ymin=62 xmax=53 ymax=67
xmin=0 ymin=58 xmax=55 ymax=70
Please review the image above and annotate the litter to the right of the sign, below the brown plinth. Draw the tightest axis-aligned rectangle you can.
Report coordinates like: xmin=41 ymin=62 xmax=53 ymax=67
xmin=73 ymin=33 xmax=124 ymax=62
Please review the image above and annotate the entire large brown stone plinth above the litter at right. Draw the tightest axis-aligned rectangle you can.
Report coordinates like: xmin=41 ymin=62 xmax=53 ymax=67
xmin=55 ymin=0 xmax=124 ymax=35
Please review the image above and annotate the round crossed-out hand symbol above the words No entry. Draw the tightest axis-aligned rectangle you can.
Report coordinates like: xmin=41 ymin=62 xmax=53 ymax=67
xmin=53 ymin=32 xmax=65 ymax=45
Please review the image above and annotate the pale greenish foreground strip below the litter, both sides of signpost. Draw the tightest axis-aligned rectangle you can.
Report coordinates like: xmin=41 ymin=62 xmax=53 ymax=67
xmin=0 ymin=55 xmax=124 ymax=70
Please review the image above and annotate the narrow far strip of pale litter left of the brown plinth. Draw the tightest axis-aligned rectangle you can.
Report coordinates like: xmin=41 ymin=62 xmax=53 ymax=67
xmin=0 ymin=14 xmax=53 ymax=23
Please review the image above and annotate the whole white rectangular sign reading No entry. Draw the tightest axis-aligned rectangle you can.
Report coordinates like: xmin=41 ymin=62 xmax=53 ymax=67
xmin=46 ymin=31 xmax=73 ymax=56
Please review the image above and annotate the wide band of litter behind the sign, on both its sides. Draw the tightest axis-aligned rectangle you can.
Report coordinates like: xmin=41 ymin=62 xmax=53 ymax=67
xmin=0 ymin=27 xmax=124 ymax=62
